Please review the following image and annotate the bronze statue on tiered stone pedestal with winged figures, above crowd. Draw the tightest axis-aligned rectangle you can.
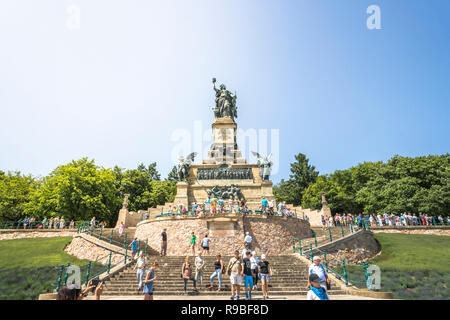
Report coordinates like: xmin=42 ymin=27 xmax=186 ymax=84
xmin=174 ymin=78 xmax=274 ymax=210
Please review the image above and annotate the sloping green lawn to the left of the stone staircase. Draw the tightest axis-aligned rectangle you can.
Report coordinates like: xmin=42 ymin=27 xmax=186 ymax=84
xmin=0 ymin=237 xmax=101 ymax=300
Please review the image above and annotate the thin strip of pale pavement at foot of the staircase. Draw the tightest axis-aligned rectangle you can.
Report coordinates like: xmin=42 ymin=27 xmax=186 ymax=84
xmin=91 ymin=295 xmax=379 ymax=301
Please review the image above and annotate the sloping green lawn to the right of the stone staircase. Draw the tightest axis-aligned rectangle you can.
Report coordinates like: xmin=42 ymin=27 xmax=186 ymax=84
xmin=338 ymin=233 xmax=450 ymax=300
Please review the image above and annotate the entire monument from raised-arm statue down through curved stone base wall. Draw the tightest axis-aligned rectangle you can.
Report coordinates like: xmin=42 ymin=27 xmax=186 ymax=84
xmin=131 ymin=79 xmax=312 ymax=256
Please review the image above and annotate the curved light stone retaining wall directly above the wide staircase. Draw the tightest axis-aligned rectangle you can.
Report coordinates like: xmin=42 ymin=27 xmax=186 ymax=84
xmin=135 ymin=216 xmax=312 ymax=255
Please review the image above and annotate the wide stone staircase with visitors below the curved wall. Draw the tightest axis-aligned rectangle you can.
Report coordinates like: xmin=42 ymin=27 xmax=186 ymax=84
xmin=103 ymin=255 xmax=345 ymax=296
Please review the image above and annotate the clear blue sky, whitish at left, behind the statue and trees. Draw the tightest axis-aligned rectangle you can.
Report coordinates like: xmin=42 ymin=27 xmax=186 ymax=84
xmin=0 ymin=0 xmax=450 ymax=182
